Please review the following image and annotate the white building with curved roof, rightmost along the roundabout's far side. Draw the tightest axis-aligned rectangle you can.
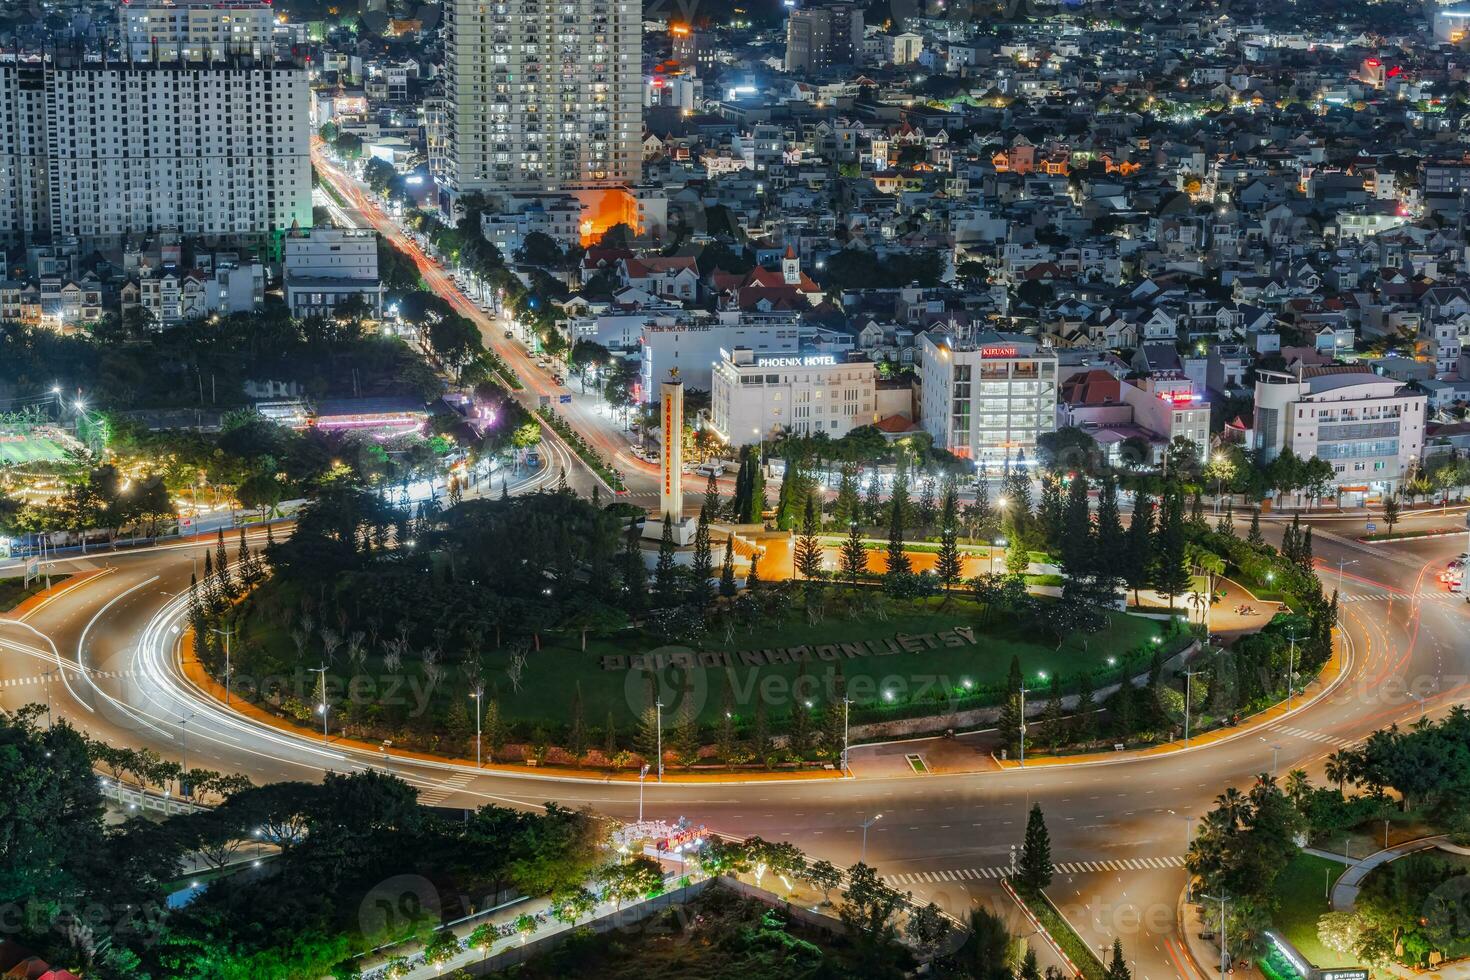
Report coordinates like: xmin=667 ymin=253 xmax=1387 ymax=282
xmin=1252 ymin=364 xmax=1427 ymax=494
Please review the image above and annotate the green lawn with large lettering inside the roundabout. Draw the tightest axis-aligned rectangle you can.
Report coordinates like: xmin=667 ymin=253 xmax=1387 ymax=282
xmin=237 ymin=597 xmax=1185 ymax=732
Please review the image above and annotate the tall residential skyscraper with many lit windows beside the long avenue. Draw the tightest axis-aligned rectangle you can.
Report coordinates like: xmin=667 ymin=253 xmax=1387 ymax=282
xmin=444 ymin=0 xmax=642 ymax=194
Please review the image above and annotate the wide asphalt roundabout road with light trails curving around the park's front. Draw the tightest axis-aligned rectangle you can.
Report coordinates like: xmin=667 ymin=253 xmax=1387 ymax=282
xmin=0 ymin=516 xmax=1470 ymax=980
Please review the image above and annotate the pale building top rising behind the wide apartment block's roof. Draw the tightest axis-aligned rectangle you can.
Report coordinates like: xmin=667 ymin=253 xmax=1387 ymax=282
xmin=118 ymin=0 xmax=275 ymax=62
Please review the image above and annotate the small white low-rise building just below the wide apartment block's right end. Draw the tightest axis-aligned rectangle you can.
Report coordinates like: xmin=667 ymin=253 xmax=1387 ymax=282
xmin=282 ymin=228 xmax=382 ymax=317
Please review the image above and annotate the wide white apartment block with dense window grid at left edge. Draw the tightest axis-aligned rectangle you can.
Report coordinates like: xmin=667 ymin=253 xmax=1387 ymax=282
xmin=0 ymin=60 xmax=312 ymax=247
